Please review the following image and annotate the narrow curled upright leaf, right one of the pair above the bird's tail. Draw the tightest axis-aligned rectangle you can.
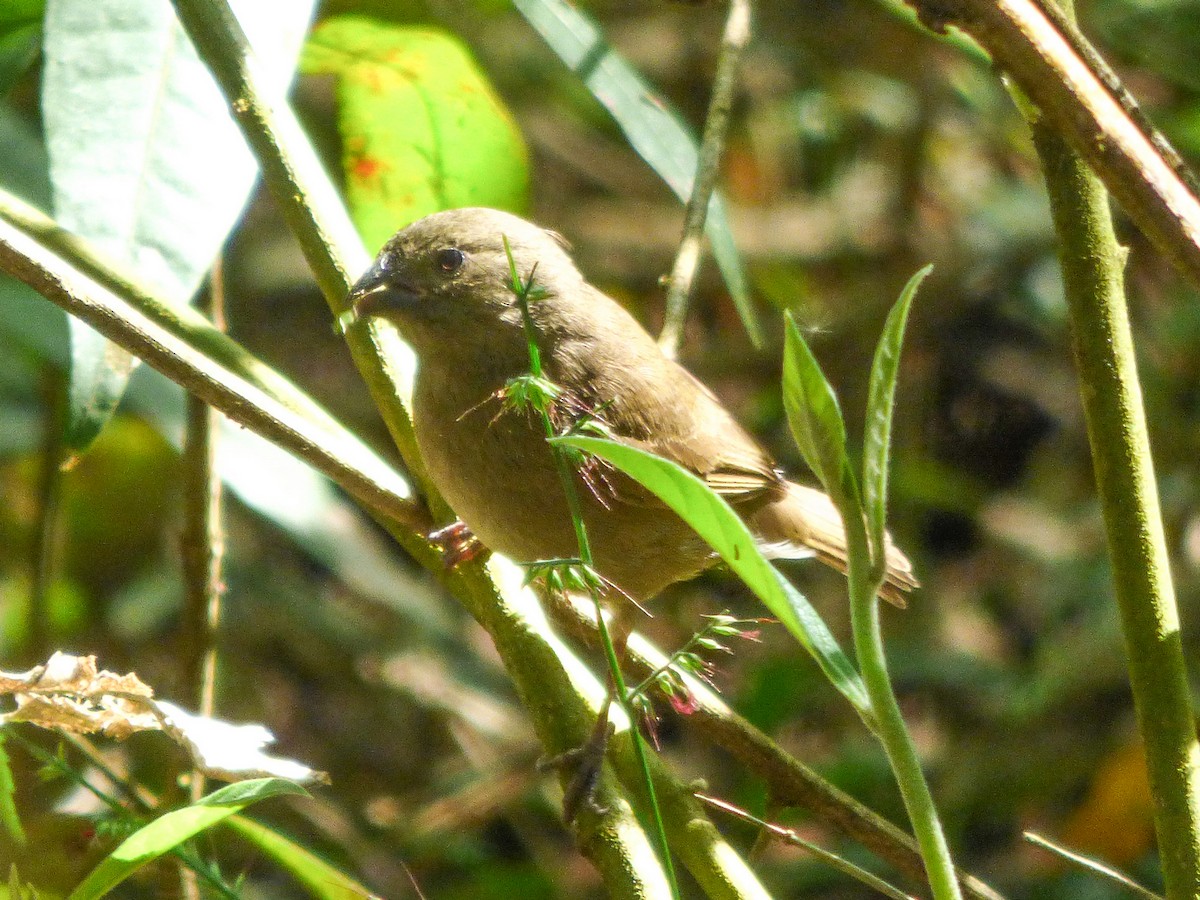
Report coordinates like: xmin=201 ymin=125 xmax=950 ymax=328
xmin=863 ymin=265 xmax=934 ymax=566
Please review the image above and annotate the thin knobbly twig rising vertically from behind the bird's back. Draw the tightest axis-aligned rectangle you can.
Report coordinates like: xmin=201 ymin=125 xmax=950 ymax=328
xmin=659 ymin=0 xmax=750 ymax=359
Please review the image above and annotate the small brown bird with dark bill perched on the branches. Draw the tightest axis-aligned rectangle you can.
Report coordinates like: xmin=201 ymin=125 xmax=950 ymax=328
xmin=349 ymin=209 xmax=917 ymax=605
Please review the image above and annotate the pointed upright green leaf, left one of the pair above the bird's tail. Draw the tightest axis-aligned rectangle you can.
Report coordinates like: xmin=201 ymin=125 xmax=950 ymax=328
xmin=784 ymin=316 xmax=848 ymax=504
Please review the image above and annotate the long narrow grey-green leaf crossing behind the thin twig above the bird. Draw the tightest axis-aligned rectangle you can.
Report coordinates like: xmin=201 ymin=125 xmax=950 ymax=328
xmin=514 ymin=0 xmax=762 ymax=346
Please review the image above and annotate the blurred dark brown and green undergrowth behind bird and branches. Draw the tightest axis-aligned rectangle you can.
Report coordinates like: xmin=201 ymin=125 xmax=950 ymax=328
xmin=0 ymin=0 xmax=1200 ymax=898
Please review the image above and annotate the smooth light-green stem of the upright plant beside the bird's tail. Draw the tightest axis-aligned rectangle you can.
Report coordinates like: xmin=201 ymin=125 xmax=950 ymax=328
xmin=842 ymin=513 xmax=962 ymax=900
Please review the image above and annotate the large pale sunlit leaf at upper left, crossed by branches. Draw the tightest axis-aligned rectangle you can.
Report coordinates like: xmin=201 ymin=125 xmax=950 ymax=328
xmin=42 ymin=0 xmax=312 ymax=451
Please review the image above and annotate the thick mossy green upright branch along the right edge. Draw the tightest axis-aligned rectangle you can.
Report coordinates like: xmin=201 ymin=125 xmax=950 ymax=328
xmin=1032 ymin=77 xmax=1200 ymax=900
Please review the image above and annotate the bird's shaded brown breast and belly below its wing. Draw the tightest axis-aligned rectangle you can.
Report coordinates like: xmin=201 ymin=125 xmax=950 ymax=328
xmin=414 ymin=376 xmax=712 ymax=600
